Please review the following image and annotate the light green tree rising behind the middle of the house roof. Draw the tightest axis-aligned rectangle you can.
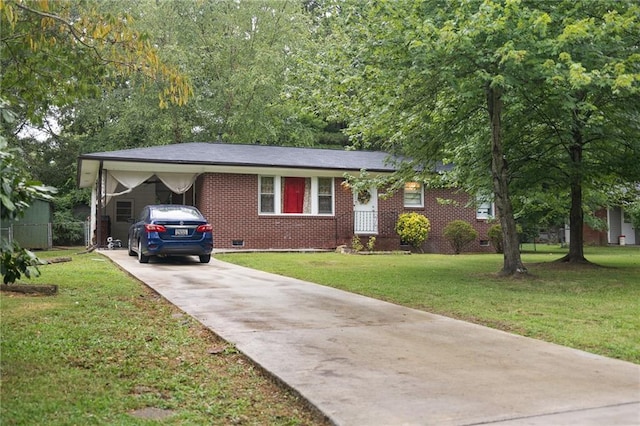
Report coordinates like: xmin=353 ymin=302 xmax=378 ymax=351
xmin=153 ymin=0 xmax=318 ymax=145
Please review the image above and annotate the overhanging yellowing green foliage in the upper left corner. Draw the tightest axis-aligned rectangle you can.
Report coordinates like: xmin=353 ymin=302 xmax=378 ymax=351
xmin=0 ymin=0 xmax=191 ymax=121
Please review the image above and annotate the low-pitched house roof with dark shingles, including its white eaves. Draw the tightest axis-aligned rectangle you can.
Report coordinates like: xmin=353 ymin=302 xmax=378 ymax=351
xmin=78 ymin=142 xmax=396 ymax=187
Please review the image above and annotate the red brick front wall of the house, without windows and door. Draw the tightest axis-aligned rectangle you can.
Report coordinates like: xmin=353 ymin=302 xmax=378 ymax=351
xmin=196 ymin=173 xmax=494 ymax=253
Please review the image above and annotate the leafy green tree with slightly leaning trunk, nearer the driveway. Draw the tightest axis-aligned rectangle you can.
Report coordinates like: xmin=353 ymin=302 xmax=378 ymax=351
xmin=300 ymin=1 xmax=536 ymax=275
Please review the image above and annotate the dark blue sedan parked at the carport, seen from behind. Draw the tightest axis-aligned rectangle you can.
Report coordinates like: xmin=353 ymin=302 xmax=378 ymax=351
xmin=128 ymin=204 xmax=213 ymax=263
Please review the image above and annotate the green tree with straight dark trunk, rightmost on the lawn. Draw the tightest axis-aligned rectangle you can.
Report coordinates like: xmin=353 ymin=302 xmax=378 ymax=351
xmin=518 ymin=0 xmax=640 ymax=262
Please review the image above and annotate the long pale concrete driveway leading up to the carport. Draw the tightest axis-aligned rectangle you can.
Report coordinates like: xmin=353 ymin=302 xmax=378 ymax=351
xmin=100 ymin=250 xmax=640 ymax=426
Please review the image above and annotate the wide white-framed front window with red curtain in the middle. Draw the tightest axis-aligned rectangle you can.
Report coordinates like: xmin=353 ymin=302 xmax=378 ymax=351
xmin=258 ymin=176 xmax=334 ymax=215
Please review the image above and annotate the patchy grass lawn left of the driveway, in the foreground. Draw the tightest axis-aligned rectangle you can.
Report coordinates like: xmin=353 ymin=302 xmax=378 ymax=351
xmin=0 ymin=249 xmax=326 ymax=425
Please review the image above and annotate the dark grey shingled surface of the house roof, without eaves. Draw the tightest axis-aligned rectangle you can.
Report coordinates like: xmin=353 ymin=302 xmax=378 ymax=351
xmin=80 ymin=142 xmax=396 ymax=172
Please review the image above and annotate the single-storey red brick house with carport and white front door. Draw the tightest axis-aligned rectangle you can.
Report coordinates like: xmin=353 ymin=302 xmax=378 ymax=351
xmin=78 ymin=143 xmax=493 ymax=253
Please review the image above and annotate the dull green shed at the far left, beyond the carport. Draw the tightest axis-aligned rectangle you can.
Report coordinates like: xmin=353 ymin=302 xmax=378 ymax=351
xmin=0 ymin=200 xmax=53 ymax=250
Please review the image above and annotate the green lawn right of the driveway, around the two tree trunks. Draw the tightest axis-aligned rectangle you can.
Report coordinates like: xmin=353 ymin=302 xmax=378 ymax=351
xmin=216 ymin=245 xmax=640 ymax=364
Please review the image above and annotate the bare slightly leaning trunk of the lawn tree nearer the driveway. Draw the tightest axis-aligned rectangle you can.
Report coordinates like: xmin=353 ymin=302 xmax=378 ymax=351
xmin=486 ymin=86 xmax=527 ymax=275
